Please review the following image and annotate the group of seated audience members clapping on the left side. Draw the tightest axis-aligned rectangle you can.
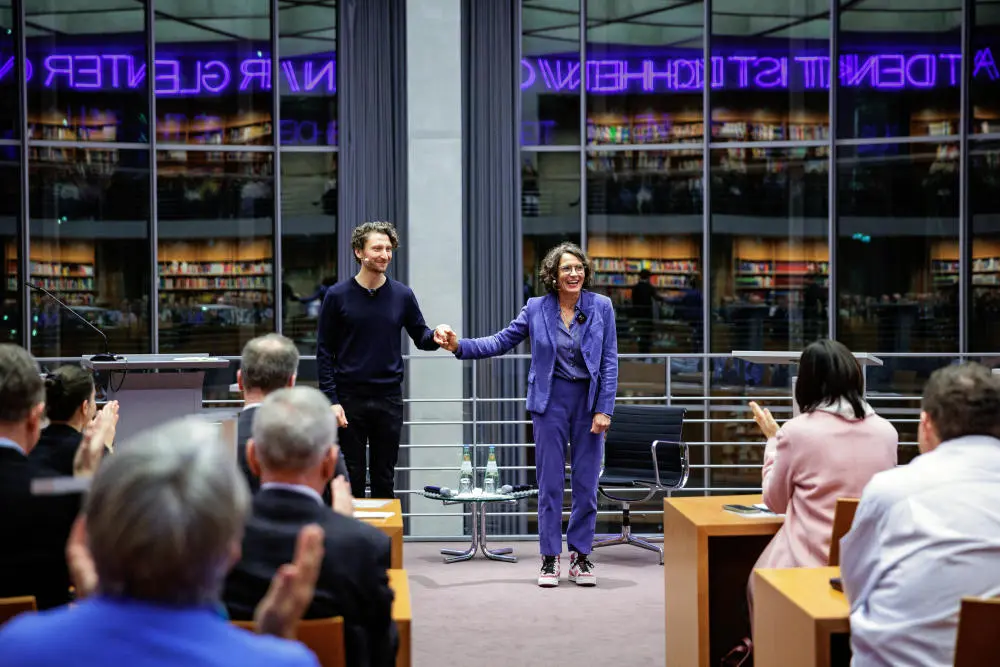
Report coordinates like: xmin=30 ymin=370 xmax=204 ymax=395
xmin=0 ymin=335 xmax=398 ymax=667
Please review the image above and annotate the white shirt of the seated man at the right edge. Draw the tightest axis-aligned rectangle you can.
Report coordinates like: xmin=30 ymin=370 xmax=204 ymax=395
xmin=840 ymin=436 xmax=1000 ymax=667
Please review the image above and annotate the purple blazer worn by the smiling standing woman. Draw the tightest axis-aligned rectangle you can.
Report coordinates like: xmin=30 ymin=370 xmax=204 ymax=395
xmin=455 ymin=291 xmax=618 ymax=415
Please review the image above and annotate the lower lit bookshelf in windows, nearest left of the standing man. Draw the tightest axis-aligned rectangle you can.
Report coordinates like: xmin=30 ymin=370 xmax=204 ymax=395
xmin=158 ymin=239 xmax=274 ymax=303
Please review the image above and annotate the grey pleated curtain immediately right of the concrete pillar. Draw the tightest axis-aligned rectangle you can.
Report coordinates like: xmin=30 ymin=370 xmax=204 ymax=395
xmin=462 ymin=0 xmax=534 ymax=533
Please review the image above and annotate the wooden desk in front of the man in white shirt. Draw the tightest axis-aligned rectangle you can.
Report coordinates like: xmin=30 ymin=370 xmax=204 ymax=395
xmin=753 ymin=567 xmax=851 ymax=667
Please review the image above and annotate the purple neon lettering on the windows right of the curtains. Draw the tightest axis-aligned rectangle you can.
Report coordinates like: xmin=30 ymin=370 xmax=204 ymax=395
xmin=521 ymin=48 xmax=1000 ymax=94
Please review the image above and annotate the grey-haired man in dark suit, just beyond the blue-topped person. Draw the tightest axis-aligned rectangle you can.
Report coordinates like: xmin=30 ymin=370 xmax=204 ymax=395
xmin=223 ymin=387 xmax=397 ymax=667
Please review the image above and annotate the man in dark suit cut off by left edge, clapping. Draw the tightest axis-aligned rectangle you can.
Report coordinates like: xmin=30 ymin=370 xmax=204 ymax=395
xmin=0 ymin=344 xmax=109 ymax=609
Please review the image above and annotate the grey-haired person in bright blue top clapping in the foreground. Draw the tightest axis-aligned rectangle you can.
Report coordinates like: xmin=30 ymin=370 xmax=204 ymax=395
xmin=0 ymin=417 xmax=322 ymax=667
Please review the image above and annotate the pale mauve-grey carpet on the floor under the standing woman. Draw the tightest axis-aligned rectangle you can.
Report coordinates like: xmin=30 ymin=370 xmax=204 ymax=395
xmin=403 ymin=542 xmax=665 ymax=667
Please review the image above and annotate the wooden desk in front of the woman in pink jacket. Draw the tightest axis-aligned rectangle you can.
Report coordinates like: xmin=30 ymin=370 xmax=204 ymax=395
xmin=663 ymin=495 xmax=784 ymax=667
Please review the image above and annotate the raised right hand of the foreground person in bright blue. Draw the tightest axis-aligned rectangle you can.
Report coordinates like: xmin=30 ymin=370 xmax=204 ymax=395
xmin=253 ymin=524 xmax=324 ymax=639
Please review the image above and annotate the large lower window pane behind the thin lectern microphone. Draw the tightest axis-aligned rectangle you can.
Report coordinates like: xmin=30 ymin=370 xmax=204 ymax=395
xmin=28 ymin=147 xmax=152 ymax=357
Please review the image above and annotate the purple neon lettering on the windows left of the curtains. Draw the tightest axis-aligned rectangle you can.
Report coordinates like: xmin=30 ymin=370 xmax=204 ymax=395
xmin=0 ymin=53 xmax=337 ymax=96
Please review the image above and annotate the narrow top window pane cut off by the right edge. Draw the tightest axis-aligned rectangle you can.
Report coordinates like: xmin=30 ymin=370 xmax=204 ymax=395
xmin=969 ymin=0 xmax=1000 ymax=134
